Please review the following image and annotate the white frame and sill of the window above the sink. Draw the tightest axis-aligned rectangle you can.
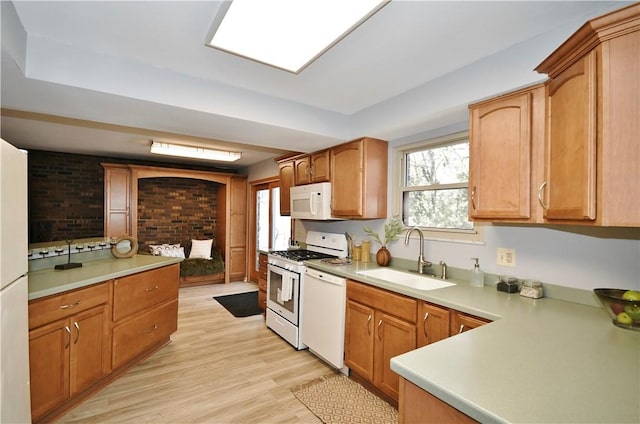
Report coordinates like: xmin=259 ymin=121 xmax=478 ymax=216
xmin=391 ymin=131 xmax=484 ymax=244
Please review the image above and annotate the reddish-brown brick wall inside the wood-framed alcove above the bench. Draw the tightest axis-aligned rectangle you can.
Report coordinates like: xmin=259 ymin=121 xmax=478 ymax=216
xmin=138 ymin=178 xmax=219 ymax=251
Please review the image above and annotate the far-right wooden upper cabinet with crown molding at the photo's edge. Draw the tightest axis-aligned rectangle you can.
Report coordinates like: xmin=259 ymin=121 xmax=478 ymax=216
xmin=536 ymin=3 xmax=640 ymax=227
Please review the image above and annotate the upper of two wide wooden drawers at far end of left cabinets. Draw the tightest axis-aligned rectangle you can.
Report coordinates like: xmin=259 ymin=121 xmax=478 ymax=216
xmin=113 ymin=264 xmax=180 ymax=321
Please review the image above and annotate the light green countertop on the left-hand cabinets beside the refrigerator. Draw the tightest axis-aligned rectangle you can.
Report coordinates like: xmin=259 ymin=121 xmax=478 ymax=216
xmin=28 ymin=255 xmax=182 ymax=300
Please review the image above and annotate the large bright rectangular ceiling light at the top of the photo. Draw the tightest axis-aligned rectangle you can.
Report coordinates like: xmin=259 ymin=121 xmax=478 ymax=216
xmin=206 ymin=0 xmax=391 ymax=73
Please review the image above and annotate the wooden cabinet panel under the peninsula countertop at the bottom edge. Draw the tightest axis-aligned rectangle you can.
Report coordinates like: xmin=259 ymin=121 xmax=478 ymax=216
xmin=398 ymin=378 xmax=477 ymax=424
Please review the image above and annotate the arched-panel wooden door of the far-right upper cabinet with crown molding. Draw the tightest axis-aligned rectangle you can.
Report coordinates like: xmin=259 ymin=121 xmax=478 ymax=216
xmin=541 ymin=51 xmax=597 ymax=220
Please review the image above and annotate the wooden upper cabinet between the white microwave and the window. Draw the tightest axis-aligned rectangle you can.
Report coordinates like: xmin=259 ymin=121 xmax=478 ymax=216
xmin=330 ymin=137 xmax=388 ymax=219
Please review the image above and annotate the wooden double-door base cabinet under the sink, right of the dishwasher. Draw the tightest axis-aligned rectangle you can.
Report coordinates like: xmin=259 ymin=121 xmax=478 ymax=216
xmin=345 ymin=280 xmax=417 ymax=401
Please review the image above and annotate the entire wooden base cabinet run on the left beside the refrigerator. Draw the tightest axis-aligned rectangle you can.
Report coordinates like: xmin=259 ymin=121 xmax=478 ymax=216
xmin=29 ymin=264 xmax=179 ymax=423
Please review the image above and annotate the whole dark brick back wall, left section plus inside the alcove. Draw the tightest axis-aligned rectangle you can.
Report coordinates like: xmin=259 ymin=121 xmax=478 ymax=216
xmin=28 ymin=150 xmax=232 ymax=243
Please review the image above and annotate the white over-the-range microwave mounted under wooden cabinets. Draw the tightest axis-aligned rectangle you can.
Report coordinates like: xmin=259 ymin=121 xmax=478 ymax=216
xmin=290 ymin=183 xmax=336 ymax=220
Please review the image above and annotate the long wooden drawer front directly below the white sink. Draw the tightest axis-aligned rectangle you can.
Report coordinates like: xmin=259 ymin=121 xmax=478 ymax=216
xmin=347 ymin=280 xmax=418 ymax=323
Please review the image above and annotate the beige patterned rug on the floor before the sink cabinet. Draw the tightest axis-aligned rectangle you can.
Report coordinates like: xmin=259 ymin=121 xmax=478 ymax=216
xmin=291 ymin=373 xmax=398 ymax=424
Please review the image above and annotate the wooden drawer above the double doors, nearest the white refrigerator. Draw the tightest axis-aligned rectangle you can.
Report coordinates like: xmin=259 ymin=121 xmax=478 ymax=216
xmin=29 ymin=282 xmax=110 ymax=329
